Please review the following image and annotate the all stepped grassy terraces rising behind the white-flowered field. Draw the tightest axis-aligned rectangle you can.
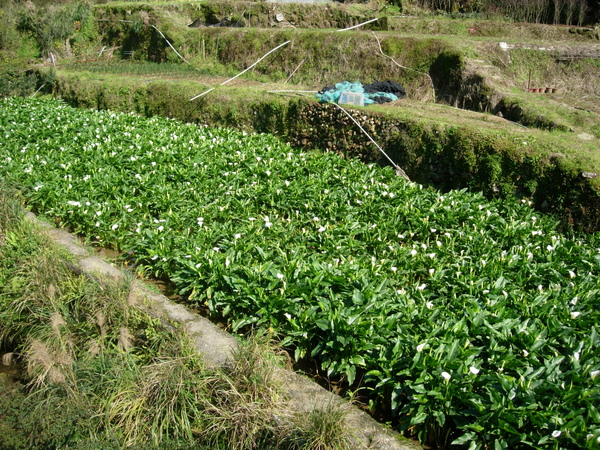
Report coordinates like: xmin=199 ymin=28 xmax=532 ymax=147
xmin=44 ymin=3 xmax=600 ymax=230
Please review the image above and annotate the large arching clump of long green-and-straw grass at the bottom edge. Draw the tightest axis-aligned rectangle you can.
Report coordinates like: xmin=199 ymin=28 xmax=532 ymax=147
xmin=106 ymin=328 xmax=293 ymax=449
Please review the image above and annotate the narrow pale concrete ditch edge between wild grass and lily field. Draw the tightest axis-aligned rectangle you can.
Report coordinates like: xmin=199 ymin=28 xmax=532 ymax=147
xmin=26 ymin=212 xmax=420 ymax=450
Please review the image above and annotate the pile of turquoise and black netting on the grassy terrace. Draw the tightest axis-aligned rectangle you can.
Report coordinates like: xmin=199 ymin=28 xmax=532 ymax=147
xmin=317 ymin=81 xmax=406 ymax=106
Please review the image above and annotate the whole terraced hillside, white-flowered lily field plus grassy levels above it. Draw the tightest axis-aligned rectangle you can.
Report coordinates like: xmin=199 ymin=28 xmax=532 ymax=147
xmin=0 ymin=2 xmax=600 ymax=448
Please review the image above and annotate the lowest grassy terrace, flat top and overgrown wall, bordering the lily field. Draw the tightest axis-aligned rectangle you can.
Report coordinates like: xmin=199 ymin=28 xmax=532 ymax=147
xmin=49 ymin=64 xmax=600 ymax=230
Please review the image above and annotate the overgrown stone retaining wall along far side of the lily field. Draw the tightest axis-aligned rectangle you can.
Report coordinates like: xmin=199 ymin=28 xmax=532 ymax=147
xmin=53 ymin=74 xmax=600 ymax=232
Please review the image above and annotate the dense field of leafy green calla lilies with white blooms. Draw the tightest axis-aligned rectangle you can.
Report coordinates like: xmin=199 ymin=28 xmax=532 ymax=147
xmin=0 ymin=99 xmax=600 ymax=448
